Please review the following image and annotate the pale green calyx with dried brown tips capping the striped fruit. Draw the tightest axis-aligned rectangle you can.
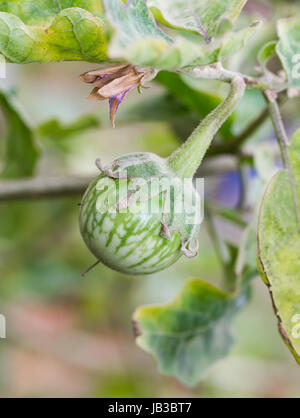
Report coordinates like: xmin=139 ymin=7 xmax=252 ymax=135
xmin=96 ymin=153 xmax=201 ymax=258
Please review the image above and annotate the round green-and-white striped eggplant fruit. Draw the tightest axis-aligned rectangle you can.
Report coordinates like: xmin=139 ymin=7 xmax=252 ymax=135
xmin=79 ymin=153 xmax=199 ymax=275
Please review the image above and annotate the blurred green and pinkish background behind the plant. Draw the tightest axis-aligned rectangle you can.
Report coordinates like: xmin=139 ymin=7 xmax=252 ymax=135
xmin=0 ymin=1 xmax=300 ymax=397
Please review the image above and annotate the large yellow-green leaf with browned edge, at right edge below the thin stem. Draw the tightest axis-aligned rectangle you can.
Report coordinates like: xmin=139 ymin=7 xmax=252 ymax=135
xmin=258 ymin=130 xmax=300 ymax=363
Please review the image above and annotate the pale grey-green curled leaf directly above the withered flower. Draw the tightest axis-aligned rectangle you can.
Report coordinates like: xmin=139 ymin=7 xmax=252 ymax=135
xmin=104 ymin=0 xmax=257 ymax=70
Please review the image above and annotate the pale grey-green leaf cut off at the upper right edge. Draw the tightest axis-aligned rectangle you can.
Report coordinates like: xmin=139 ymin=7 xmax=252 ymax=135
xmin=276 ymin=16 xmax=300 ymax=88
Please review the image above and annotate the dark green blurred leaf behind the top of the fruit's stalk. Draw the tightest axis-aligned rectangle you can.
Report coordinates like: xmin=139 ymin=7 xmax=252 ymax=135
xmin=155 ymin=71 xmax=235 ymax=139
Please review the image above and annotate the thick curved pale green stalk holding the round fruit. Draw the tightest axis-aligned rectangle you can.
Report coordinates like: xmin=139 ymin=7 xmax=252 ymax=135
xmin=168 ymin=75 xmax=245 ymax=178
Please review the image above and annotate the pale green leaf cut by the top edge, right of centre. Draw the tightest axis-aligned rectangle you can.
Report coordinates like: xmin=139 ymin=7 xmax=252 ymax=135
xmin=148 ymin=0 xmax=247 ymax=37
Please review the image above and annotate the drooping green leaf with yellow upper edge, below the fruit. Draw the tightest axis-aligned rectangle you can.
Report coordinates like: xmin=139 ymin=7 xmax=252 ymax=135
xmin=134 ymin=279 xmax=241 ymax=386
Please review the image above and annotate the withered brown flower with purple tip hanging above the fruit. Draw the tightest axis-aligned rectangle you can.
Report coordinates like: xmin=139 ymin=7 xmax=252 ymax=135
xmin=80 ymin=63 xmax=146 ymax=127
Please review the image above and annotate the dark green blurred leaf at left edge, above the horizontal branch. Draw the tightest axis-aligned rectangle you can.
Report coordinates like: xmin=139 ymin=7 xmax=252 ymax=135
xmin=0 ymin=91 xmax=38 ymax=178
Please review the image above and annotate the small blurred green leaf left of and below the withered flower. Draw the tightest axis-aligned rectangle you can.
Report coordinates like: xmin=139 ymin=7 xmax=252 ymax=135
xmin=37 ymin=115 xmax=100 ymax=142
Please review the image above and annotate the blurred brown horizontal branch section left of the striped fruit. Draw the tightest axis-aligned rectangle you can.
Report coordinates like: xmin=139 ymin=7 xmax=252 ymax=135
xmin=0 ymin=176 xmax=93 ymax=202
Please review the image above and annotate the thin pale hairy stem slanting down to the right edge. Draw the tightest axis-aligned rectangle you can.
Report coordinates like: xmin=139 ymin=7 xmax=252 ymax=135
xmin=265 ymin=93 xmax=300 ymax=232
